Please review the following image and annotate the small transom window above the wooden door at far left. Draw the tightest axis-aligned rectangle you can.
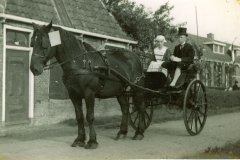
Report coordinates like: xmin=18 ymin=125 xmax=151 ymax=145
xmin=6 ymin=29 xmax=30 ymax=47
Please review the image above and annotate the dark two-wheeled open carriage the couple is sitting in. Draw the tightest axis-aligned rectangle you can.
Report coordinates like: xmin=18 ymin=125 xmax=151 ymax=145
xmin=126 ymin=64 xmax=208 ymax=136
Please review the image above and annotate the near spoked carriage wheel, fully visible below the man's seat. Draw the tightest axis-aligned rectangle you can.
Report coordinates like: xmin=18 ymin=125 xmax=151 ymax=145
xmin=183 ymin=79 xmax=207 ymax=136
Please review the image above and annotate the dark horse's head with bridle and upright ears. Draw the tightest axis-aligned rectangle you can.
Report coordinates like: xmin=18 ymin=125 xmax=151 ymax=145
xmin=30 ymin=22 xmax=56 ymax=75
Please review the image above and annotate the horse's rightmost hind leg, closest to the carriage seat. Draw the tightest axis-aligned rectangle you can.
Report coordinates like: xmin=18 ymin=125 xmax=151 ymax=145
xmin=133 ymin=92 xmax=145 ymax=140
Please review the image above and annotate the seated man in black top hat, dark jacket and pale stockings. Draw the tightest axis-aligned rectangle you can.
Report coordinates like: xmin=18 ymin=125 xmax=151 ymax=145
xmin=162 ymin=27 xmax=195 ymax=91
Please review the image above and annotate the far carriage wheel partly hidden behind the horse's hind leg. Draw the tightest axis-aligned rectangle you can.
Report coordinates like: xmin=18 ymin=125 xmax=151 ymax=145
xmin=128 ymin=97 xmax=153 ymax=130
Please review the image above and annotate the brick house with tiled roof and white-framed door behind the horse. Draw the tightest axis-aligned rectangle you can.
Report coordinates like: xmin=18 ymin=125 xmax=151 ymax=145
xmin=0 ymin=0 xmax=137 ymax=128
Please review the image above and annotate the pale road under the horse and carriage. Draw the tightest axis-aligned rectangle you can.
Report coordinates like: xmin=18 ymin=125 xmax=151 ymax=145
xmin=0 ymin=112 xmax=240 ymax=160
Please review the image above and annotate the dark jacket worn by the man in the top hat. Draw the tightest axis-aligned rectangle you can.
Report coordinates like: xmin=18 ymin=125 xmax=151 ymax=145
xmin=173 ymin=43 xmax=195 ymax=64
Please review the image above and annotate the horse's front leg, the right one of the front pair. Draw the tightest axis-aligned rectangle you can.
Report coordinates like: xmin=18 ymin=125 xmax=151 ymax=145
xmin=85 ymin=91 xmax=98 ymax=149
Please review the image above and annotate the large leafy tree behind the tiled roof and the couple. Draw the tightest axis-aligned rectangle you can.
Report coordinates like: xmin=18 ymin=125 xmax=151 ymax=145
xmin=102 ymin=0 xmax=186 ymax=49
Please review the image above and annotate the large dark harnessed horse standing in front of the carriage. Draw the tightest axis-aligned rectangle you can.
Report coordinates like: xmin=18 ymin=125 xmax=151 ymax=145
xmin=30 ymin=22 xmax=145 ymax=149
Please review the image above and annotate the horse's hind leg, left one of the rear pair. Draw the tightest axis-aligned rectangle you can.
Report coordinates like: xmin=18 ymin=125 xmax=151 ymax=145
xmin=115 ymin=93 xmax=129 ymax=140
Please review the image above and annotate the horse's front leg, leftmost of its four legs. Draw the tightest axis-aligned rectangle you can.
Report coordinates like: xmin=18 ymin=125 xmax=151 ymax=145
xmin=69 ymin=92 xmax=86 ymax=147
